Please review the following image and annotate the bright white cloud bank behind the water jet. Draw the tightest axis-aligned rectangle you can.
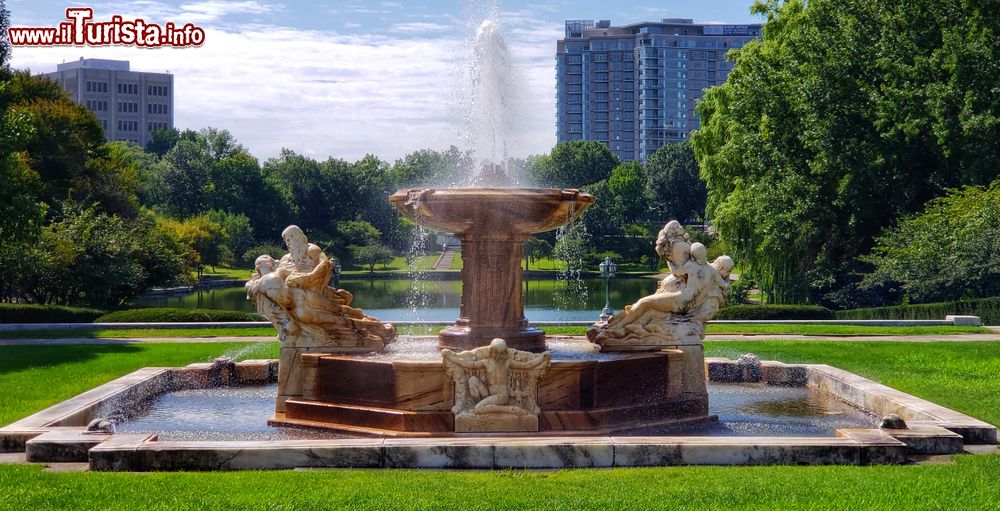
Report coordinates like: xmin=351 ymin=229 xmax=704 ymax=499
xmin=7 ymin=1 xmax=562 ymax=160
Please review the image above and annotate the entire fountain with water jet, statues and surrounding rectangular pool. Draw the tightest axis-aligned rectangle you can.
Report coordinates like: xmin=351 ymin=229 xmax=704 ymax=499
xmin=0 ymin=8 xmax=997 ymax=471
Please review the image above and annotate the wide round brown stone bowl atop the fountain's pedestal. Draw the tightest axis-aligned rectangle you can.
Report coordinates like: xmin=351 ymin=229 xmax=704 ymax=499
xmin=389 ymin=188 xmax=595 ymax=234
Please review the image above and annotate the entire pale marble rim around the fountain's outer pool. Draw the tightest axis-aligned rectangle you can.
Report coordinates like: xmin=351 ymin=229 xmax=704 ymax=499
xmin=0 ymin=358 xmax=997 ymax=471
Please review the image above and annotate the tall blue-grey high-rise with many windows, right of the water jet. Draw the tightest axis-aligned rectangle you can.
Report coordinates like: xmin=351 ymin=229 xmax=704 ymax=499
xmin=556 ymin=19 xmax=761 ymax=161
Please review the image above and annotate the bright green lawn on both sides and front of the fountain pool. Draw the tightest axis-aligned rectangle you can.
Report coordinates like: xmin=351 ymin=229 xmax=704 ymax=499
xmin=0 ymin=341 xmax=1000 ymax=510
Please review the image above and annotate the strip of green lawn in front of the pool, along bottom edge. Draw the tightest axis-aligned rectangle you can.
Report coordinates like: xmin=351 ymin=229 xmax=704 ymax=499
xmin=0 ymin=456 xmax=1000 ymax=511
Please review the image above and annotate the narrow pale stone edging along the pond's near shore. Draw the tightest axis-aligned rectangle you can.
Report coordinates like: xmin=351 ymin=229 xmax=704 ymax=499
xmin=0 ymin=316 xmax=981 ymax=332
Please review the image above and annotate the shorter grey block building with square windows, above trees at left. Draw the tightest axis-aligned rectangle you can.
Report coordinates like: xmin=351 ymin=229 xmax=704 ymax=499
xmin=43 ymin=58 xmax=174 ymax=147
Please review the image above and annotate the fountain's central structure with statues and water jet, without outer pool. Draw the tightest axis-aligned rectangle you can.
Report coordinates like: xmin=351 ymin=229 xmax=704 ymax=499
xmin=234 ymin=13 xmax=732 ymax=436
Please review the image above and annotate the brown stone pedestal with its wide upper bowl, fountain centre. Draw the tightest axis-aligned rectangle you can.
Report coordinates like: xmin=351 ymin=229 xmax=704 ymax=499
xmin=389 ymin=188 xmax=594 ymax=351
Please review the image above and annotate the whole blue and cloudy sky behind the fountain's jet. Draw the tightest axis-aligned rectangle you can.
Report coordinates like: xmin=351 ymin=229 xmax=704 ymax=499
xmin=7 ymin=0 xmax=761 ymax=161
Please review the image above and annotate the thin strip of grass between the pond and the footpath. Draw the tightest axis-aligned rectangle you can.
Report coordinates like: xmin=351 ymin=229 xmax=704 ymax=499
xmin=0 ymin=323 xmax=994 ymax=339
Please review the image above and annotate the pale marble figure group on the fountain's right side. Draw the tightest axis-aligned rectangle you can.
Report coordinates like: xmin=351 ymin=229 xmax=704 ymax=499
xmin=587 ymin=220 xmax=733 ymax=349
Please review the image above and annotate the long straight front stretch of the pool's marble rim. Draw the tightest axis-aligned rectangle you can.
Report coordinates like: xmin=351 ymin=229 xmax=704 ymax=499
xmin=89 ymin=434 xmax=906 ymax=471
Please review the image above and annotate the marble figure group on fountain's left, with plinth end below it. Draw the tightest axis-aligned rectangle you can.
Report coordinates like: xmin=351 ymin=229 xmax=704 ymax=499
xmin=246 ymin=225 xmax=396 ymax=412
